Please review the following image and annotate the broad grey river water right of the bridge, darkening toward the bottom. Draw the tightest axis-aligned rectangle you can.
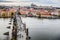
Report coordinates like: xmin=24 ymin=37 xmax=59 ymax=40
xmin=22 ymin=17 xmax=60 ymax=40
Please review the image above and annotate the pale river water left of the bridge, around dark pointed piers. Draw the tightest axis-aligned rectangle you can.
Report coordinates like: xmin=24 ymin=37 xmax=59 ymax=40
xmin=0 ymin=18 xmax=13 ymax=40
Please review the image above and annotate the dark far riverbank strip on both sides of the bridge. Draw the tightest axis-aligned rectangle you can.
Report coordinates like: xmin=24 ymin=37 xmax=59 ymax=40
xmin=0 ymin=15 xmax=60 ymax=19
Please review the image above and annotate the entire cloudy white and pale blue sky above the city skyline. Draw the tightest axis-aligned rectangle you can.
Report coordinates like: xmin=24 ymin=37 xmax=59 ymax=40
xmin=0 ymin=0 xmax=60 ymax=7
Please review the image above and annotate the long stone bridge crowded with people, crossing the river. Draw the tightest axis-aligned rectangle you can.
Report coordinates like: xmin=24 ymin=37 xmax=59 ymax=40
xmin=11 ymin=14 xmax=29 ymax=40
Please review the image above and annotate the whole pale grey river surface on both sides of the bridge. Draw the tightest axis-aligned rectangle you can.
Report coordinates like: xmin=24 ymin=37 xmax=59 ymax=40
xmin=0 ymin=17 xmax=60 ymax=40
